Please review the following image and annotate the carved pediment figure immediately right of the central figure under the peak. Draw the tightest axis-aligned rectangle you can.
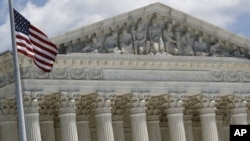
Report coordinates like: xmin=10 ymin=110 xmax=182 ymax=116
xmin=163 ymin=24 xmax=178 ymax=55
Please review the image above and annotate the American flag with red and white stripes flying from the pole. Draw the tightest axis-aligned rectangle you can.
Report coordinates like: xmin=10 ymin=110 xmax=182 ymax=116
xmin=14 ymin=9 xmax=58 ymax=72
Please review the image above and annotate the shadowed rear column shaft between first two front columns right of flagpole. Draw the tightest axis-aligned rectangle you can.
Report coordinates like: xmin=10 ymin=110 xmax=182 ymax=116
xmin=40 ymin=115 xmax=55 ymax=141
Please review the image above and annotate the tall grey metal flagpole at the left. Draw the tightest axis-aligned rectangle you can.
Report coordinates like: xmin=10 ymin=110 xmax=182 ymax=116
xmin=8 ymin=0 xmax=27 ymax=141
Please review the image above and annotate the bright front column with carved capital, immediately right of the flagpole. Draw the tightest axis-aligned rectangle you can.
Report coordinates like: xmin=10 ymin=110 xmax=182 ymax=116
xmin=24 ymin=92 xmax=41 ymax=141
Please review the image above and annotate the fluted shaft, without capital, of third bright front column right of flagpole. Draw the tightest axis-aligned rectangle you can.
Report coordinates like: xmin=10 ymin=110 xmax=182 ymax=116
xmin=95 ymin=107 xmax=114 ymax=141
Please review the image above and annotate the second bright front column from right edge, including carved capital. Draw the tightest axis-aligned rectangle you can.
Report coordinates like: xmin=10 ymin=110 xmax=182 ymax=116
xmin=200 ymin=96 xmax=219 ymax=141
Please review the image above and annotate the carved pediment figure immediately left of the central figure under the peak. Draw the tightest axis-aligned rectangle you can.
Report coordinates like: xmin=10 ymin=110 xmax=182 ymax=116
xmin=132 ymin=22 xmax=149 ymax=54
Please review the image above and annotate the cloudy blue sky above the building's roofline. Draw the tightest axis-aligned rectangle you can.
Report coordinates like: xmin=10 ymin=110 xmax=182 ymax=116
xmin=0 ymin=0 xmax=250 ymax=52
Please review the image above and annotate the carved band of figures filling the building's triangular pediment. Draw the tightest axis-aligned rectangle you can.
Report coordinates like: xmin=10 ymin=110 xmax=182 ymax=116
xmin=60 ymin=13 xmax=250 ymax=58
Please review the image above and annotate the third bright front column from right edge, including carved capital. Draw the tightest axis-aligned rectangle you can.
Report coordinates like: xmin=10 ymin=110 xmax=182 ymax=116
xmin=164 ymin=95 xmax=186 ymax=141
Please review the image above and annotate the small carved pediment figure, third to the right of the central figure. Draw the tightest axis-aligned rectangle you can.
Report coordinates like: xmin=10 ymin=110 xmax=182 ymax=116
xmin=194 ymin=36 xmax=208 ymax=56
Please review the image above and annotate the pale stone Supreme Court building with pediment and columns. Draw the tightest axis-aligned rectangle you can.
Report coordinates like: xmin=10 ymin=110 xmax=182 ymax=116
xmin=0 ymin=3 xmax=250 ymax=141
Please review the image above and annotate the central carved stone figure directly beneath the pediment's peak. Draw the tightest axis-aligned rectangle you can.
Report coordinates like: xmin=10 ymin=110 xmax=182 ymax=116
xmin=148 ymin=18 xmax=165 ymax=55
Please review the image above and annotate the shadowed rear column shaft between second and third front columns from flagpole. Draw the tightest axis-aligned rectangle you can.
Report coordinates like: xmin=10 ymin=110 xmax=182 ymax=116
xmin=76 ymin=115 xmax=91 ymax=141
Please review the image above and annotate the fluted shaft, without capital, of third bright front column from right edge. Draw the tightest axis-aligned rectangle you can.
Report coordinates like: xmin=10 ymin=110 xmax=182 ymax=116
xmin=167 ymin=108 xmax=186 ymax=141
